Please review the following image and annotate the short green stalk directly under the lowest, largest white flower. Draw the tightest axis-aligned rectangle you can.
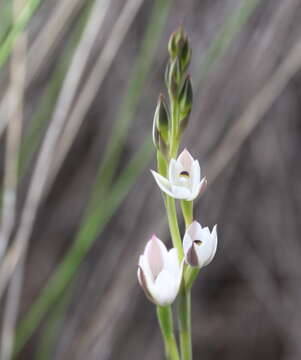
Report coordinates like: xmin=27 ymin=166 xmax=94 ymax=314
xmin=157 ymin=306 xmax=180 ymax=360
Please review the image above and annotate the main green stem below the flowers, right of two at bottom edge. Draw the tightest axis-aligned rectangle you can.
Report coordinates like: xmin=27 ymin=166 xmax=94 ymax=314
xmin=178 ymin=286 xmax=192 ymax=360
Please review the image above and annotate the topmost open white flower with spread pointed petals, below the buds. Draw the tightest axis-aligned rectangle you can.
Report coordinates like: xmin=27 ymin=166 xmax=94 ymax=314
xmin=151 ymin=149 xmax=207 ymax=201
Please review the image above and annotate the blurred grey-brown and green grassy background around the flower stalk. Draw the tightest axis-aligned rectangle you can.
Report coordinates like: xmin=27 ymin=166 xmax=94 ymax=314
xmin=0 ymin=0 xmax=301 ymax=360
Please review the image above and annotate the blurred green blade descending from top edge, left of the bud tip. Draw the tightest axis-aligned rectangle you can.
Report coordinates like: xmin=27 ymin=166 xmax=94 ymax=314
xmin=88 ymin=0 xmax=172 ymax=211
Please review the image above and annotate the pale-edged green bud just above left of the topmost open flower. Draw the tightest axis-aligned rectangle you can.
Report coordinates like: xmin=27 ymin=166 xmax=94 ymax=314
xmin=153 ymin=94 xmax=169 ymax=154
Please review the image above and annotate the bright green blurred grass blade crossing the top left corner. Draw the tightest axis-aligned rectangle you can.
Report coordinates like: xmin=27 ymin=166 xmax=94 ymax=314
xmin=0 ymin=0 xmax=43 ymax=68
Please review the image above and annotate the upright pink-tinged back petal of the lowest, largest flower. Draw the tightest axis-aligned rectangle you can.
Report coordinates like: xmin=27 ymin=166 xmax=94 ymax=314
xmin=144 ymin=235 xmax=167 ymax=278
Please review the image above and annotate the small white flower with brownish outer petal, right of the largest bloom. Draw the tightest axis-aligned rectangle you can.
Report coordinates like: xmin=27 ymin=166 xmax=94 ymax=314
xmin=183 ymin=221 xmax=217 ymax=268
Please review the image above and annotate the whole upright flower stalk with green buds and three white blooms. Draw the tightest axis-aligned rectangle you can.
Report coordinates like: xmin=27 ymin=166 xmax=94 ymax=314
xmin=138 ymin=27 xmax=217 ymax=360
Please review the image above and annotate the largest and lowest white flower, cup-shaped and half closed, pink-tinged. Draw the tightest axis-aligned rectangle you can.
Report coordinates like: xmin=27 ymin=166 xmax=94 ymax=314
xmin=138 ymin=235 xmax=184 ymax=306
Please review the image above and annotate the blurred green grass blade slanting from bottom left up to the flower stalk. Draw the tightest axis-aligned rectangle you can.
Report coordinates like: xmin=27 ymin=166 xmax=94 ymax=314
xmin=15 ymin=141 xmax=152 ymax=353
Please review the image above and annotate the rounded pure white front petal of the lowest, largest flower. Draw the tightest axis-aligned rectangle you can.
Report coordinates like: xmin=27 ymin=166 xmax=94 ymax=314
xmin=154 ymin=270 xmax=178 ymax=306
